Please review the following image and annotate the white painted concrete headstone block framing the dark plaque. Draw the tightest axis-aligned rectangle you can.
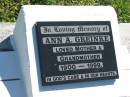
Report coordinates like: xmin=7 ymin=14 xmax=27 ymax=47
xmin=14 ymin=6 xmax=129 ymax=97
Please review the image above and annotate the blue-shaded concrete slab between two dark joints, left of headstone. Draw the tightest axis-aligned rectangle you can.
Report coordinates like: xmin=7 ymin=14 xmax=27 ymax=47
xmin=0 ymin=51 xmax=21 ymax=80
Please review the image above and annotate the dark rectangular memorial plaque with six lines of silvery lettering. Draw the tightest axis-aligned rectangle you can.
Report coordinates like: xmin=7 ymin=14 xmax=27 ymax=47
xmin=36 ymin=21 xmax=119 ymax=85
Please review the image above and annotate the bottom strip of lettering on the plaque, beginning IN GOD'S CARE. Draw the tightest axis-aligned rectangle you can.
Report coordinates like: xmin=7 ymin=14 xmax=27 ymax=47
xmin=46 ymin=71 xmax=117 ymax=82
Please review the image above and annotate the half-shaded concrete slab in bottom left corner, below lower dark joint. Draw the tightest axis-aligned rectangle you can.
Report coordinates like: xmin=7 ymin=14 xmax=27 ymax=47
xmin=0 ymin=80 xmax=27 ymax=97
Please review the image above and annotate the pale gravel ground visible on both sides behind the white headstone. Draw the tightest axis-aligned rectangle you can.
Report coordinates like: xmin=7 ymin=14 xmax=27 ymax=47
xmin=0 ymin=23 xmax=130 ymax=53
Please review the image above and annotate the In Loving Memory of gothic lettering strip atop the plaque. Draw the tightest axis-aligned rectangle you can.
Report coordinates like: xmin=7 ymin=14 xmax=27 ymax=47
xmin=40 ymin=25 xmax=109 ymax=34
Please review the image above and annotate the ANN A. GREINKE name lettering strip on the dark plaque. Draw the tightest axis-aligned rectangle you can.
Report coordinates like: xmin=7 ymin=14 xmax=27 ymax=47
xmin=42 ymin=35 xmax=110 ymax=44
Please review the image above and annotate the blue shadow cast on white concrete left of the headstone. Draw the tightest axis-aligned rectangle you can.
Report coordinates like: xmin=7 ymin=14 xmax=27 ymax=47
xmin=0 ymin=37 xmax=27 ymax=97
